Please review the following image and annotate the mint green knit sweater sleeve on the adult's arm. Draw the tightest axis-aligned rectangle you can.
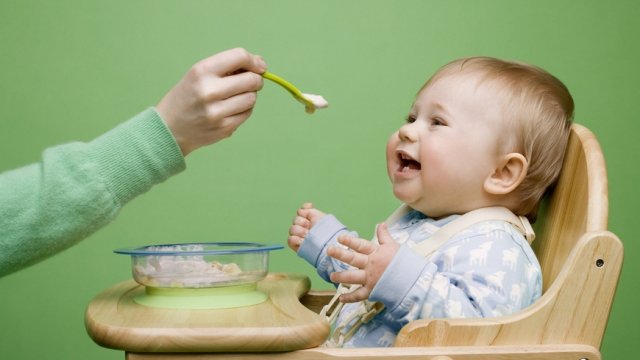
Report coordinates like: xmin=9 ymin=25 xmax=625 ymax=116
xmin=0 ymin=108 xmax=185 ymax=277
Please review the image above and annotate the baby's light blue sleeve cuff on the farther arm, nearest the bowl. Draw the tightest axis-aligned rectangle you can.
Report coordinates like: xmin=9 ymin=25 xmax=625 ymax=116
xmin=298 ymin=215 xmax=358 ymax=282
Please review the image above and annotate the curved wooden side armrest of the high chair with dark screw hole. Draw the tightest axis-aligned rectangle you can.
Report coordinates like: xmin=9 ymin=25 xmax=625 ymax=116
xmin=394 ymin=231 xmax=623 ymax=349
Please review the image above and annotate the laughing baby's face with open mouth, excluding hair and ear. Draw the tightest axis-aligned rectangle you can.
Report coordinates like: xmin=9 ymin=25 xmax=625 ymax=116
xmin=387 ymin=70 xmax=504 ymax=217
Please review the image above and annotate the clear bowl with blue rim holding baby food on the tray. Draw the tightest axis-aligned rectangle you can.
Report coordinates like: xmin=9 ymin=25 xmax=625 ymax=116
xmin=114 ymin=242 xmax=283 ymax=289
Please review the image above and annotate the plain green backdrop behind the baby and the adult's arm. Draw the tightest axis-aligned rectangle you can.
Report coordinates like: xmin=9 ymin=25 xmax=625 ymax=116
xmin=0 ymin=0 xmax=640 ymax=359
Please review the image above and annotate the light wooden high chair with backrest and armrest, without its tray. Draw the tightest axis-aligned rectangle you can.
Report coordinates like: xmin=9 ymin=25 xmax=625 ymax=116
xmin=90 ymin=125 xmax=623 ymax=360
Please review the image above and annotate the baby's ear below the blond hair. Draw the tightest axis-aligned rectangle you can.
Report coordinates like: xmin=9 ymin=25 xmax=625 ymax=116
xmin=484 ymin=153 xmax=529 ymax=195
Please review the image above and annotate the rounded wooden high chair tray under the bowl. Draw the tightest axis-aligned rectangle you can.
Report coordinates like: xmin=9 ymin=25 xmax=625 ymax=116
xmin=85 ymin=273 xmax=329 ymax=352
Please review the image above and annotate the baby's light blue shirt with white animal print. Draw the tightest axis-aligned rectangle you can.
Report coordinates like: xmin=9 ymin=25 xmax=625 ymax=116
xmin=298 ymin=210 xmax=542 ymax=347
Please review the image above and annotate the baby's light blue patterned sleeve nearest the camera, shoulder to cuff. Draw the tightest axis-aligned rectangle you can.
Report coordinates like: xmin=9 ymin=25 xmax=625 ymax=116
xmin=370 ymin=226 xmax=542 ymax=326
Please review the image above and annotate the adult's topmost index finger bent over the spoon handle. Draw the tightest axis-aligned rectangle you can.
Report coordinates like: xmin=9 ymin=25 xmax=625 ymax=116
xmin=198 ymin=48 xmax=267 ymax=76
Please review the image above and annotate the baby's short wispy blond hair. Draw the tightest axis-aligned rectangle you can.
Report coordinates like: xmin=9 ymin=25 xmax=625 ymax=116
xmin=423 ymin=57 xmax=574 ymax=221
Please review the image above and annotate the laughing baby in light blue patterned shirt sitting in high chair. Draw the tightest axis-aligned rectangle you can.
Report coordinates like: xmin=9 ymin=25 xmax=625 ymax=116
xmin=288 ymin=57 xmax=573 ymax=347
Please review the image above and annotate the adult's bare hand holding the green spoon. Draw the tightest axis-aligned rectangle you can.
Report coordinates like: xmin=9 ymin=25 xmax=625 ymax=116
xmin=156 ymin=48 xmax=267 ymax=156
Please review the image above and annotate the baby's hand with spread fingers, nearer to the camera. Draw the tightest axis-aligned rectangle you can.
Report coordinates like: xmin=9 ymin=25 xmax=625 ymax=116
xmin=327 ymin=223 xmax=400 ymax=303
